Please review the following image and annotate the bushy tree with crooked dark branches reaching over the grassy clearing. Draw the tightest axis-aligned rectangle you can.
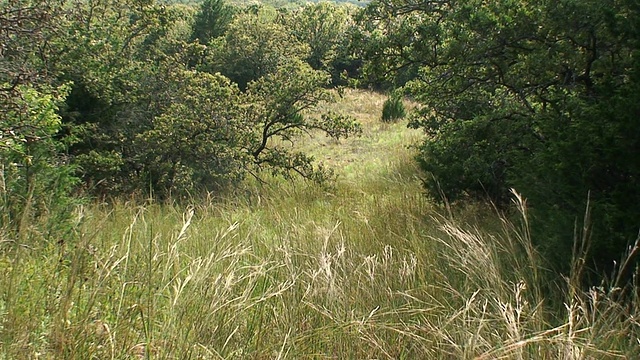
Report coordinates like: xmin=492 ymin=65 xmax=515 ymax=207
xmin=138 ymin=61 xmax=359 ymax=196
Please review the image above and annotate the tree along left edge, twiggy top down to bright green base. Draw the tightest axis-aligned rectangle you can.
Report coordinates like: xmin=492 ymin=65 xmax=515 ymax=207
xmin=0 ymin=1 xmax=75 ymax=233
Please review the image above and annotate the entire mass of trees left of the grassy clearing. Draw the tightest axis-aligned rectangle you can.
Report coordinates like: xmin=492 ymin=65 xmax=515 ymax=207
xmin=0 ymin=0 xmax=358 ymax=204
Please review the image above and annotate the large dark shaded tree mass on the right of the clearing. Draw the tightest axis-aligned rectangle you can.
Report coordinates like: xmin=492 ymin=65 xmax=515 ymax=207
xmin=367 ymin=0 xmax=640 ymax=276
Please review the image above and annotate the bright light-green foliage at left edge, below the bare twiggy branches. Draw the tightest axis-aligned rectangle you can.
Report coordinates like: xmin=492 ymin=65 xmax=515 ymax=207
xmin=0 ymin=85 xmax=77 ymax=234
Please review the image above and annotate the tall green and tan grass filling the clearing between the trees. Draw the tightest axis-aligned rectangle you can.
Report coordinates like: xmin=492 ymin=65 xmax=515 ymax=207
xmin=0 ymin=90 xmax=640 ymax=359
